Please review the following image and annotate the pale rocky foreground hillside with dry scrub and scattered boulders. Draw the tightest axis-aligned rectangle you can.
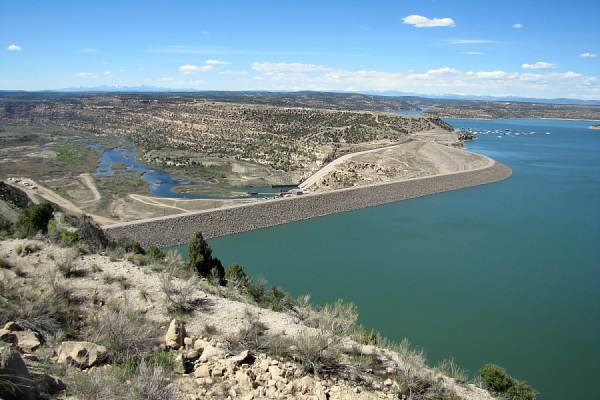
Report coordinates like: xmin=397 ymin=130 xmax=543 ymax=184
xmin=0 ymin=238 xmax=492 ymax=399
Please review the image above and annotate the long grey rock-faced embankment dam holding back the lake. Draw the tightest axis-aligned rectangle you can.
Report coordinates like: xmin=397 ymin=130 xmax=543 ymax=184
xmin=102 ymin=156 xmax=512 ymax=247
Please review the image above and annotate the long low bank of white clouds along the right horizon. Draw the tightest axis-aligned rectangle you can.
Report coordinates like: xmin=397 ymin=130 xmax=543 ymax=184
xmin=246 ymin=63 xmax=600 ymax=98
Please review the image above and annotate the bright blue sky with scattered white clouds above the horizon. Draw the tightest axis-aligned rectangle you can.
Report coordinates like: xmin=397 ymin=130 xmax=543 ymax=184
xmin=0 ymin=0 xmax=600 ymax=100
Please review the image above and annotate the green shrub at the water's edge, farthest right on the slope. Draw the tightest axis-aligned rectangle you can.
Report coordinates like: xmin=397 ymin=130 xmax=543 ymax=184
xmin=479 ymin=364 xmax=539 ymax=400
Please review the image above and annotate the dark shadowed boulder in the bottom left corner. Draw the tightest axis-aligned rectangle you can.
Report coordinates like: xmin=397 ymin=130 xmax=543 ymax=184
xmin=0 ymin=348 xmax=37 ymax=400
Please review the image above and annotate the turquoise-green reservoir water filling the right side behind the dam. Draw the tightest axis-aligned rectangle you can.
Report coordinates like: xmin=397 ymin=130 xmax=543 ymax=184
xmin=171 ymin=120 xmax=600 ymax=399
